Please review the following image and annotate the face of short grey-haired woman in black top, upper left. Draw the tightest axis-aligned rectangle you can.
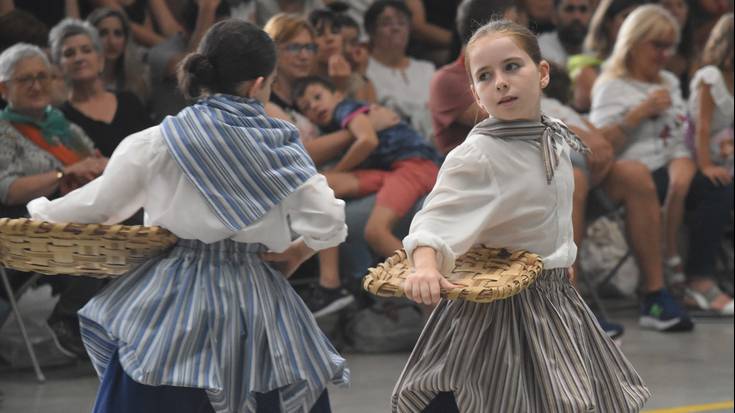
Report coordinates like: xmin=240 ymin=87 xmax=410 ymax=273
xmin=60 ymin=34 xmax=104 ymax=81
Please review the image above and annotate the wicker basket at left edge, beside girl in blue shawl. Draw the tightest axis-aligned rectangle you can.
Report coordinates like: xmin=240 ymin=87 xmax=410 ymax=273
xmin=0 ymin=218 xmax=177 ymax=278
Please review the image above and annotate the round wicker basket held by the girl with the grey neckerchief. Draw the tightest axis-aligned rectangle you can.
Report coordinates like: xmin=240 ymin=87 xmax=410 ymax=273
xmin=362 ymin=246 xmax=543 ymax=303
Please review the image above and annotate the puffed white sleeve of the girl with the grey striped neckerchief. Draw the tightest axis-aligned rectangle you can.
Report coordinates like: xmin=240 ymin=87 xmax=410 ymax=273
xmin=403 ymin=141 xmax=499 ymax=275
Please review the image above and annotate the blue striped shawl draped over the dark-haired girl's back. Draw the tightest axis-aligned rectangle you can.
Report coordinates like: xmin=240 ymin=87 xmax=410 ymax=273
xmin=161 ymin=95 xmax=316 ymax=231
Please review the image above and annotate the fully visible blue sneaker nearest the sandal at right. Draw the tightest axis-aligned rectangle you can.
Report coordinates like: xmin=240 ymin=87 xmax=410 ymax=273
xmin=640 ymin=289 xmax=694 ymax=332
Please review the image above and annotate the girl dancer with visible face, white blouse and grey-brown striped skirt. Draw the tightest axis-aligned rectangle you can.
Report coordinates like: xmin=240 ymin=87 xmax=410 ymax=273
xmin=392 ymin=20 xmax=650 ymax=413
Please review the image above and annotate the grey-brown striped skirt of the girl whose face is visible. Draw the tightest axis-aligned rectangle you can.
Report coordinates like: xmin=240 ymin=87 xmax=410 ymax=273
xmin=392 ymin=269 xmax=650 ymax=413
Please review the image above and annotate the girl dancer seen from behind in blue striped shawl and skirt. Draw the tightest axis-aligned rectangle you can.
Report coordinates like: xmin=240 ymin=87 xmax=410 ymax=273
xmin=28 ymin=19 xmax=349 ymax=413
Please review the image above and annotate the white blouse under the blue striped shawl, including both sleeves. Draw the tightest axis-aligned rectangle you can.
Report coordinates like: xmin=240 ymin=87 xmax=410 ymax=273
xmin=28 ymin=126 xmax=347 ymax=252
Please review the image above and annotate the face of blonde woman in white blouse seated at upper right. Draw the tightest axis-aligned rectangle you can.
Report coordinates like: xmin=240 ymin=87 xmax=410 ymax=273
xmin=628 ymin=29 xmax=676 ymax=80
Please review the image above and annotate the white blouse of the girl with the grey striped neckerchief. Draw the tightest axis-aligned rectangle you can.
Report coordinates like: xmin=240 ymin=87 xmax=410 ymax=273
xmin=403 ymin=129 xmax=577 ymax=274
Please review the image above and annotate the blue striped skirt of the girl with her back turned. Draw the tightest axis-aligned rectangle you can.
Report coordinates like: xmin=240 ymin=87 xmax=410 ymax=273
xmin=79 ymin=240 xmax=349 ymax=413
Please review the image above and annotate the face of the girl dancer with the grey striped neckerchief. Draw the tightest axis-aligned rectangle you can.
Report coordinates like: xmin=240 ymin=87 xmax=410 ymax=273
xmin=467 ymin=33 xmax=549 ymax=120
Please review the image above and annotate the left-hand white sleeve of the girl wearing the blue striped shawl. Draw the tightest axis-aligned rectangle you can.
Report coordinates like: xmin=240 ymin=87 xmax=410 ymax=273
xmin=27 ymin=132 xmax=154 ymax=224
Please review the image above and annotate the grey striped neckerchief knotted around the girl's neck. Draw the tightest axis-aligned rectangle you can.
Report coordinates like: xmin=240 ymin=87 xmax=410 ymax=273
xmin=470 ymin=114 xmax=590 ymax=184
